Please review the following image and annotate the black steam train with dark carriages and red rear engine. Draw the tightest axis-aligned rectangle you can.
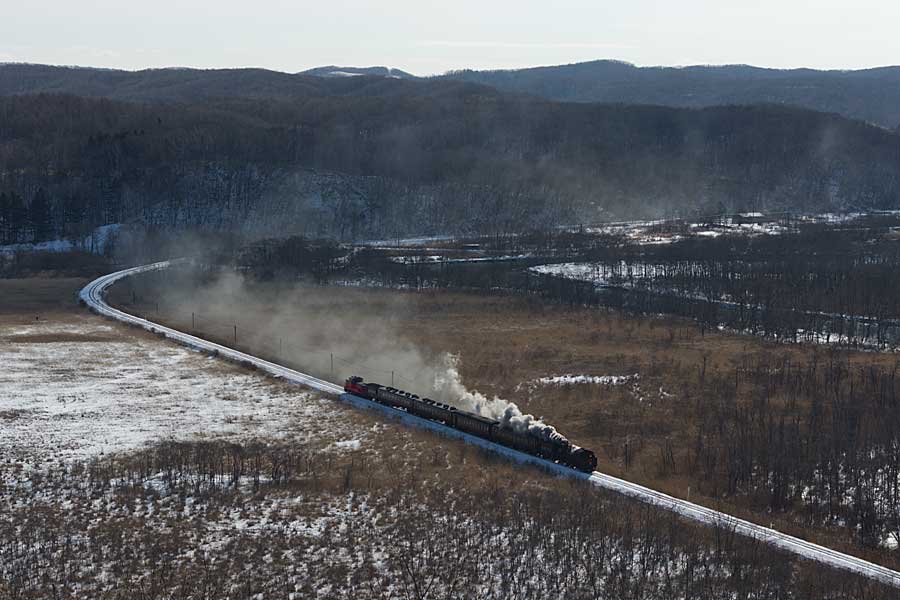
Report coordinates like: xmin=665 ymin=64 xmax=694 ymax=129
xmin=344 ymin=377 xmax=597 ymax=473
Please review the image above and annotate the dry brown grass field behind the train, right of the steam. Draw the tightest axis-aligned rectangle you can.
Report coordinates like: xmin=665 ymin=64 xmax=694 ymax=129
xmin=109 ymin=284 xmax=896 ymax=564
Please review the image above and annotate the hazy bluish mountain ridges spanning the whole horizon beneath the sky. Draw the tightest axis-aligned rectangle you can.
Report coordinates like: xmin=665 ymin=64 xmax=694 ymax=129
xmin=7 ymin=60 xmax=900 ymax=131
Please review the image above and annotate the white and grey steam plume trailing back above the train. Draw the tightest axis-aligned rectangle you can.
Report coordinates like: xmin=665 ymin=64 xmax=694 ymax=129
xmin=148 ymin=270 xmax=566 ymax=441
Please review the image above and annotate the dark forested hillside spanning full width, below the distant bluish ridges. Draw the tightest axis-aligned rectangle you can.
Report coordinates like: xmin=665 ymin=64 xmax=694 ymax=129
xmin=0 ymin=77 xmax=900 ymax=242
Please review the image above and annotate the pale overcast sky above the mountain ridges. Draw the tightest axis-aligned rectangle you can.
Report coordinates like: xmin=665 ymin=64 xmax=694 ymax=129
xmin=0 ymin=0 xmax=900 ymax=75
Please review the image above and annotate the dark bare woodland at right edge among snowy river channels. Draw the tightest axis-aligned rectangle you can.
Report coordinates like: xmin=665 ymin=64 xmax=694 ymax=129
xmin=552 ymin=215 xmax=900 ymax=348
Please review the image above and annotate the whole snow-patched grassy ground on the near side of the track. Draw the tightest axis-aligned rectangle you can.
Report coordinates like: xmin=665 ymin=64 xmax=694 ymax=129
xmin=0 ymin=278 xmax=892 ymax=598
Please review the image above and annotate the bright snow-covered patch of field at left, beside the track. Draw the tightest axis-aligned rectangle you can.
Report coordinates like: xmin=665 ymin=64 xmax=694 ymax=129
xmin=0 ymin=317 xmax=364 ymax=462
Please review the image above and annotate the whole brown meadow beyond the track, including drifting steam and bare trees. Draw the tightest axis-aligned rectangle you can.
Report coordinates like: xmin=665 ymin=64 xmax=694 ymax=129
xmin=113 ymin=275 xmax=900 ymax=566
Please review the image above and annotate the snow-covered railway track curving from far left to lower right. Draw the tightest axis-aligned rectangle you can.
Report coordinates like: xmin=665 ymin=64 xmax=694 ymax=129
xmin=79 ymin=260 xmax=900 ymax=588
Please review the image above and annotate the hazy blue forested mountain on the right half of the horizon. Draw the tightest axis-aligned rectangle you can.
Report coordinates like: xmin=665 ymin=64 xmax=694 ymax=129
xmin=444 ymin=60 xmax=900 ymax=129
